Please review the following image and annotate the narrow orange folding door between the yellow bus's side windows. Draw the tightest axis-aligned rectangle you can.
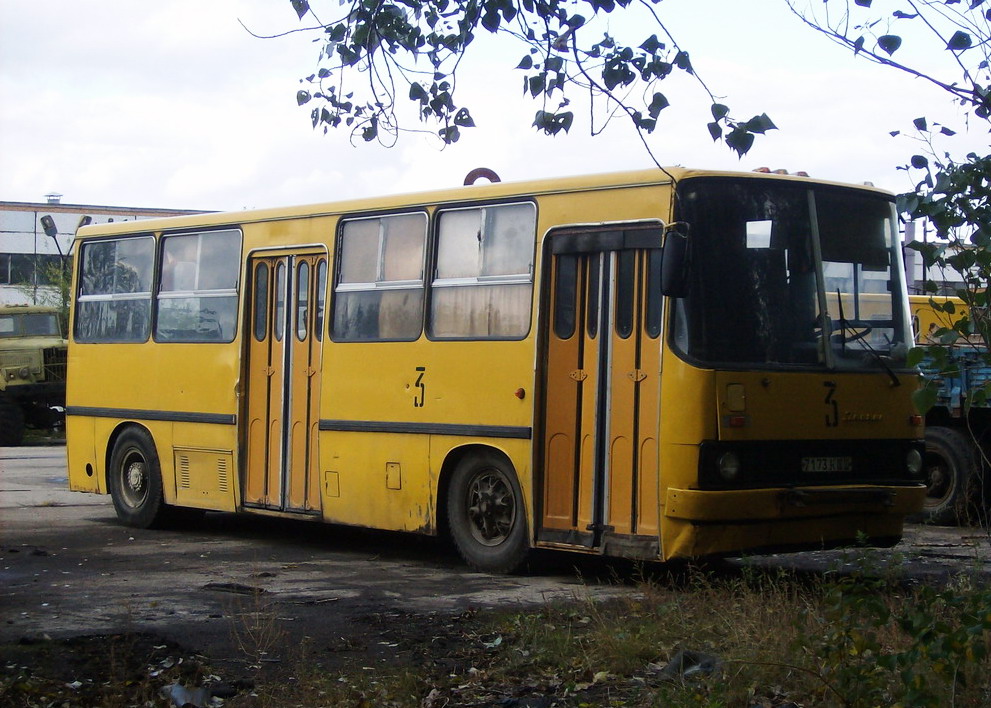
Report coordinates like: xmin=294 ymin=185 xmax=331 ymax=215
xmin=242 ymin=252 xmax=327 ymax=514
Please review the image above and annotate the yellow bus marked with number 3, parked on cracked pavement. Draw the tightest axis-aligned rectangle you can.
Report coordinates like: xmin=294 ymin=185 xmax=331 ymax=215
xmin=66 ymin=168 xmax=925 ymax=572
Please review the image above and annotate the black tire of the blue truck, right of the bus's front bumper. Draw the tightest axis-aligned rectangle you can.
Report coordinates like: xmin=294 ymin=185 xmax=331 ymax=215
xmin=922 ymin=426 xmax=980 ymax=526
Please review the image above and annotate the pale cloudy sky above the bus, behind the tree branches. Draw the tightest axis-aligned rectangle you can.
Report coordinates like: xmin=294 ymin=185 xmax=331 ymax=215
xmin=0 ymin=0 xmax=989 ymax=211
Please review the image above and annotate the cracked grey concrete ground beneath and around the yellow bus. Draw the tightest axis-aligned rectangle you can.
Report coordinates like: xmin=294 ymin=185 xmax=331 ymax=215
xmin=0 ymin=446 xmax=991 ymax=655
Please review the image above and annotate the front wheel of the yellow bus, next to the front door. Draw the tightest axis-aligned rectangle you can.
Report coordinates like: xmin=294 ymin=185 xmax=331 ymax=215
xmin=447 ymin=452 xmax=530 ymax=573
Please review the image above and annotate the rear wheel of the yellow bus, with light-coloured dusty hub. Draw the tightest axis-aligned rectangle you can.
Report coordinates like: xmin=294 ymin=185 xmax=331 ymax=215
xmin=107 ymin=428 xmax=168 ymax=529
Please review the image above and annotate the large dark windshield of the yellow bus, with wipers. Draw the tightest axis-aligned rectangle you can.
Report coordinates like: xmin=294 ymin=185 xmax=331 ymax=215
xmin=673 ymin=178 xmax=908 ymax=369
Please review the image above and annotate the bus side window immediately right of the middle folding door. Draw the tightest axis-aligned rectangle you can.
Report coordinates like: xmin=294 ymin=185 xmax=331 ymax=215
xmin=331 ymin=213 xmax=427 ymax=342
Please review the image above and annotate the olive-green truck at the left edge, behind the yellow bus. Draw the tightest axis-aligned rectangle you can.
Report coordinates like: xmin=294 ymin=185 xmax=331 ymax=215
xmin=0 ymin=305 xmax=68 ymax=446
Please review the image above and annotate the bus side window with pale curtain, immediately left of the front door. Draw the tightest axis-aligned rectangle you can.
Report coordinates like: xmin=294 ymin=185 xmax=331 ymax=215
xmin=430 ymin=203 xmax=536 ymax=339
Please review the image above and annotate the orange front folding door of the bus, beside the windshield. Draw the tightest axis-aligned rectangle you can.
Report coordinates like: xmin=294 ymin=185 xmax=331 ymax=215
xmin=537 ymin=224 xmax=661 ymax=558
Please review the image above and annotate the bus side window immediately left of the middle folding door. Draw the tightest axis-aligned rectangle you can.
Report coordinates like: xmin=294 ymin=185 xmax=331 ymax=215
xmin=155 ymin=230 xmax=241 ymax=342
